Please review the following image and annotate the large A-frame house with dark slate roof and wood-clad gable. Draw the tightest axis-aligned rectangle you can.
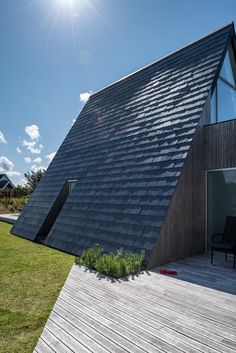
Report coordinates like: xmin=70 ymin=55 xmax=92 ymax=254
xmin=12 ymin=24 xmax=236 ymax=267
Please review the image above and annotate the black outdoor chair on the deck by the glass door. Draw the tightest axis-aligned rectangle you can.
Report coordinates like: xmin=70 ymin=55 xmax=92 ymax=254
xmin=211 ymin=216 xmax=236 ymax=269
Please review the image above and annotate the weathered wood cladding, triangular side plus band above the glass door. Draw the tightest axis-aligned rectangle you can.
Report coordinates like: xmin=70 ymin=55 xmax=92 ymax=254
xmin=149 ymin=104 xmax=236 ymax=268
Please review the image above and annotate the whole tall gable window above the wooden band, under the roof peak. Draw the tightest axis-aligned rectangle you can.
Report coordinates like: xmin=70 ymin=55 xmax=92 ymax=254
xmin=211 ymin=47 xmax=236 ymax=123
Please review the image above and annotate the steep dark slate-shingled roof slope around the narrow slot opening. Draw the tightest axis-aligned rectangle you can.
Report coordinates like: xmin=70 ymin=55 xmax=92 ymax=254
xmin=13 ymin=25 xmax=233 ymax=254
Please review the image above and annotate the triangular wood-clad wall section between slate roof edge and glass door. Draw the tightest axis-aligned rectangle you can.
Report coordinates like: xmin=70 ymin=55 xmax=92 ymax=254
xmin=148 ymin=101 xmax=209 ymax=268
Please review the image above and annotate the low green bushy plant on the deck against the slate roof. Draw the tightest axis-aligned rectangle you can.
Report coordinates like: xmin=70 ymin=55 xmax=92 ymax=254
xmin=75 ymin=245 xmax=145 ymax=278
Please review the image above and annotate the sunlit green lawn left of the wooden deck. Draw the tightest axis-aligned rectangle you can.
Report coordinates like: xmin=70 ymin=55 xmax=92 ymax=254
xmin=0 ymin=222 xmax=74 ymax=353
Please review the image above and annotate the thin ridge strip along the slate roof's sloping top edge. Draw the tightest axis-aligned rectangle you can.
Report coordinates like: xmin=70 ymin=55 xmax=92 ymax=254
xmin=91 ymin=21 xmax=234 ymax=96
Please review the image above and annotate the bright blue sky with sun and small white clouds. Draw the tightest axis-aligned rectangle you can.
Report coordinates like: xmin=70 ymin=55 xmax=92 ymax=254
xmin=0 ymin=0 xmax=236 ymax=184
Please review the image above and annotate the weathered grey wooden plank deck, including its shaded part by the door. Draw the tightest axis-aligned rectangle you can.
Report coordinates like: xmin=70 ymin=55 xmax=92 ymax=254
xmin=34 ymin=254 xmax=236 ymax=353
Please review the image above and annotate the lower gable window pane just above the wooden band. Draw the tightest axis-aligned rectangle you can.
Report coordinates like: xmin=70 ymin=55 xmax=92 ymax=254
xmin=218 ymin=79 xmax=236 ymax=122
